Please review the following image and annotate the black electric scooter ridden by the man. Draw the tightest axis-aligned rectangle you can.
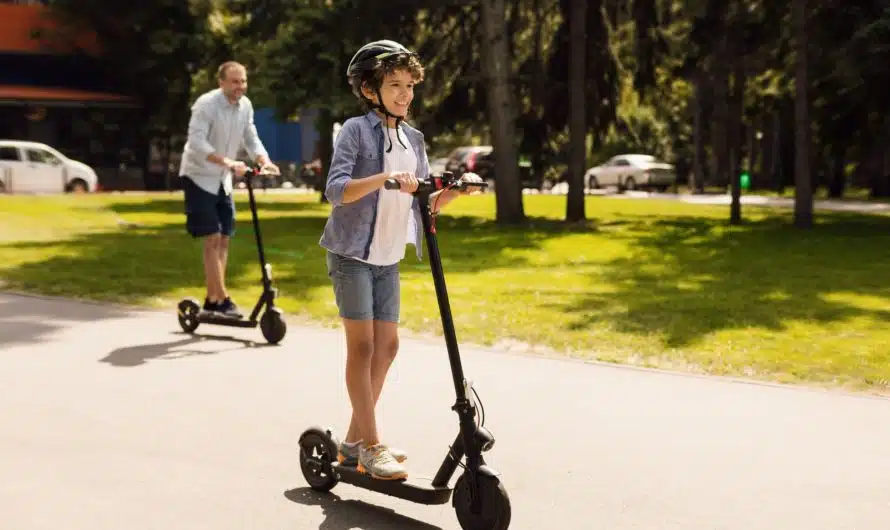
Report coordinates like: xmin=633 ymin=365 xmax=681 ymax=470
xmin=177 ymin=168 xmax=287 ymax=344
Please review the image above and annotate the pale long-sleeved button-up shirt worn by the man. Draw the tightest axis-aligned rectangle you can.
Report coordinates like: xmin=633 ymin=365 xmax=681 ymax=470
xmin=179 ymin=88 xmax=269 ymax=195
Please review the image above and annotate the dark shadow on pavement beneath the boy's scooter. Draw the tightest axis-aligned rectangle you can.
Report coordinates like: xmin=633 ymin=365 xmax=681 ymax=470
xmin=284 ymin=488 xmax=442 ymax=530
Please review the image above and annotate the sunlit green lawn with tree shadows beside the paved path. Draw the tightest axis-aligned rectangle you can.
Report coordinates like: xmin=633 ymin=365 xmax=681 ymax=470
xmin=0 ymin=193 xmax=890 ymax=393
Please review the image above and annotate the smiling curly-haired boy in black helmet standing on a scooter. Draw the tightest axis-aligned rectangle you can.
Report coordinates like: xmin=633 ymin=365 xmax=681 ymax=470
xmin=320 ymin=40 xmax=481 ymax=480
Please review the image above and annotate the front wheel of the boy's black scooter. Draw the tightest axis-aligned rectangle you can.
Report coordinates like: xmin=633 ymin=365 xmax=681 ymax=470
xmin=452 ymin=472 xmax=511 ymax=530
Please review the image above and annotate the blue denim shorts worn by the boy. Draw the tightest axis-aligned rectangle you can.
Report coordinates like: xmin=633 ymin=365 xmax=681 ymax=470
xmin=327 ymin=251 xmax=399 ymax=323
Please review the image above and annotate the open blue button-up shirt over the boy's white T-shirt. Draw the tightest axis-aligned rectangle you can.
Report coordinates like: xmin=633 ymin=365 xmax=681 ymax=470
xmin=319 ymin=111 xmax=430 ymax=260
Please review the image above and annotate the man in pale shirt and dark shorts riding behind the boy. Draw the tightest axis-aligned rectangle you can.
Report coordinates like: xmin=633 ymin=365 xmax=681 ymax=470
xmin=179 ymin=61 xmax=279 ymax=318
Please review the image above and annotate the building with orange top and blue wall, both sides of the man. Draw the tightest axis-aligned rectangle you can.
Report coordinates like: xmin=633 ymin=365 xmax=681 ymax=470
xmin=0 ymin=0 xmax=319 ymax=189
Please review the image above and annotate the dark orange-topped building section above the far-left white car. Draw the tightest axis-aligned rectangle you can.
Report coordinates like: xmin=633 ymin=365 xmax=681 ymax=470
xmin=0 ymin=0 xmax=144 ymax=188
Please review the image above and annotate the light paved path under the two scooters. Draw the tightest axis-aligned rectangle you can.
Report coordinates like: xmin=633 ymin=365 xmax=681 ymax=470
xmin=0 ymin=294 xmax=890 ymax=530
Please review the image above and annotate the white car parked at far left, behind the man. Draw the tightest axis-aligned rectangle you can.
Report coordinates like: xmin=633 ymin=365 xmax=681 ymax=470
xmin=0 ymin=140 xmax=99 ymax=193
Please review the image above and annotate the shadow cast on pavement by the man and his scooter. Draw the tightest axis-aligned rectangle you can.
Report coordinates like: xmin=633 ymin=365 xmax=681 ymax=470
xmin=99 ymin=332 xmax=271 ymax=368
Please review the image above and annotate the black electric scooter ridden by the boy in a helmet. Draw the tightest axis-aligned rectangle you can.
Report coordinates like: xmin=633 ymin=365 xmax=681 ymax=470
xmin=299 ymin=172 xmax=511 ymax=530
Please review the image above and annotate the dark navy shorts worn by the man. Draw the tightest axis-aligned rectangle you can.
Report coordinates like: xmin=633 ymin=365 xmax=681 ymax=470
xmin=182 ymin=176 xmax=235 ymax=237
